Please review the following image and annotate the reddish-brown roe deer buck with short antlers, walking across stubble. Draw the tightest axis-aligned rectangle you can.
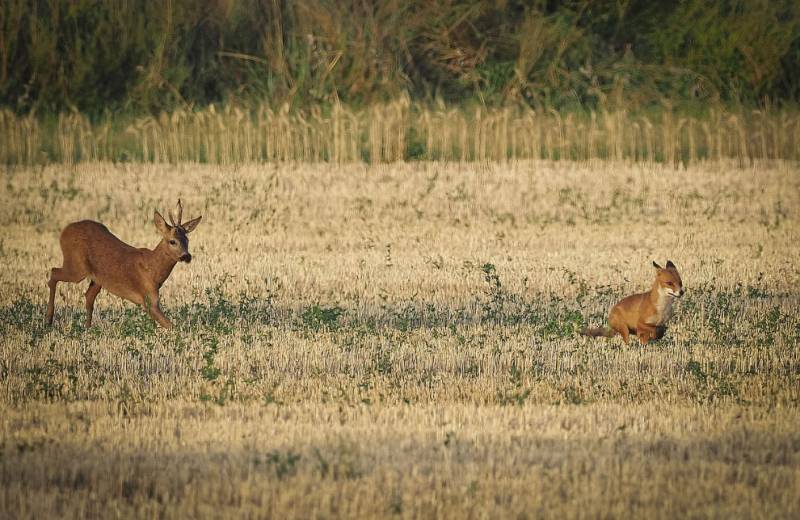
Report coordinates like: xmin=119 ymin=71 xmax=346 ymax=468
xmin=47 ymin=199 xmax=203 ymax=328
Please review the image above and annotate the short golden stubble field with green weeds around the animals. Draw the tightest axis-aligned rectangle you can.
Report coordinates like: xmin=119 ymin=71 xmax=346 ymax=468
xmin=0 ymin=162 xmax=800 ymax=518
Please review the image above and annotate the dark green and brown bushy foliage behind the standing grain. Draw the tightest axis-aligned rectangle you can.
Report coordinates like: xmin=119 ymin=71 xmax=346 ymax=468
xmin=0 ymin=0 xmax=800 ymax=118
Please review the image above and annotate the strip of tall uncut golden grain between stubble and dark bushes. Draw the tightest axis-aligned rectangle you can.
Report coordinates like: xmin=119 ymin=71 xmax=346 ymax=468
xmin=0 ymin=101 xmax=800 ymax=166
